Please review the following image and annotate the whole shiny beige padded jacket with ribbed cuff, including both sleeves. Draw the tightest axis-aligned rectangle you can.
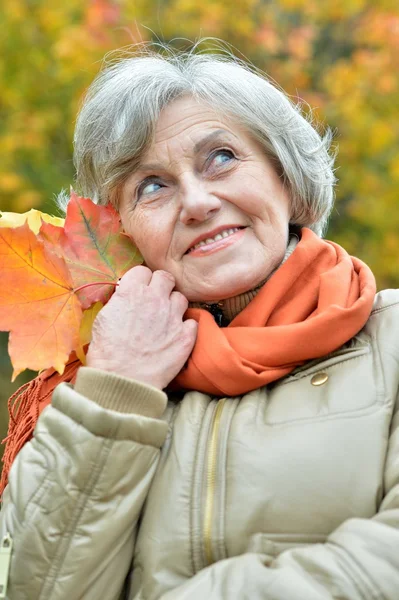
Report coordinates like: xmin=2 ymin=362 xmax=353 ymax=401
xmin=1 ymin=290 xmax=399 ymax=600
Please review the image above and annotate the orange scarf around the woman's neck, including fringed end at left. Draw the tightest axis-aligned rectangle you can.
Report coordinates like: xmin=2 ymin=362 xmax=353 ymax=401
xmin=0 ymin=228 xmax=376 ymax=493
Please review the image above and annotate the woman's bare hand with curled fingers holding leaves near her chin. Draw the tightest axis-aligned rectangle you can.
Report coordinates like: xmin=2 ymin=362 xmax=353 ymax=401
xmin=86 ymin=266 xmax=197 ymax=389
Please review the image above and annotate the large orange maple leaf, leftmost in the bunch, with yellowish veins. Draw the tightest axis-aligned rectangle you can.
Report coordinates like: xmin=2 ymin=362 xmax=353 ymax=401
xmin=0 ymin=223 xmax=82 ymax=380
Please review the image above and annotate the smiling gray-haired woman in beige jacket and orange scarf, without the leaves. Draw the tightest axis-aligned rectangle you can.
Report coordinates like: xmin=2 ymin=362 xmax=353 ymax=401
xmin=1 ymin=45 xmax=399 ymax=600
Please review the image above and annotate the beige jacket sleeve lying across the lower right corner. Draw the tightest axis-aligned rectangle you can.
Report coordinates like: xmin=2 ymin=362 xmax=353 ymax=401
xmin=162 ymin=384 xmax=399 ymax=600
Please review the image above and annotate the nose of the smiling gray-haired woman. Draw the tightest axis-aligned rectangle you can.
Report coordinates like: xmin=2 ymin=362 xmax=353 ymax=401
xmin=180 ymin=181 xmax=221 ymax=225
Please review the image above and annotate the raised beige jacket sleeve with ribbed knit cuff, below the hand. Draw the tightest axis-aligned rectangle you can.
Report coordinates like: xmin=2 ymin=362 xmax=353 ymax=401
xmin=0 ymin=368 xmax=167 ymax=600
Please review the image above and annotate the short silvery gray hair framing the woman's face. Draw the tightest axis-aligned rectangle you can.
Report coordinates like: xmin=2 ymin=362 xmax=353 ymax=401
xmin=58 ymin=45 xmax=335 ymax=235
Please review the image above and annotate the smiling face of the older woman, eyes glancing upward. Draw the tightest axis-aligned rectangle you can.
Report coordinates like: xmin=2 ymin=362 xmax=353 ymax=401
xmin=120 ymin=97 xmax=290 ymax=302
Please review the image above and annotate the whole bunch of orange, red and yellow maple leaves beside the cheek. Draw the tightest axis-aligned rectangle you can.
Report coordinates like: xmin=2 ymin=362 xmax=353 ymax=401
xmin=0 ymin=193 xmax=142 ymax=378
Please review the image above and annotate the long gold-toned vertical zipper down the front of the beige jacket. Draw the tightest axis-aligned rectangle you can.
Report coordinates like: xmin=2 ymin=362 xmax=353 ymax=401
xmin=203 ymin=398 xmax=226 ymax=565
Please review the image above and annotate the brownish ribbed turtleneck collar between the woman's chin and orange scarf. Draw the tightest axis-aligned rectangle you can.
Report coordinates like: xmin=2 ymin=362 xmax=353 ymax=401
xmin=189 ymin=233 xmax=299 ymax=324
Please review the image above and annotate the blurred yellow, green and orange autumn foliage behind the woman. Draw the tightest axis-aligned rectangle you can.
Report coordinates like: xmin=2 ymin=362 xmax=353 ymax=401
xmin=0 ymin=0 xmax=399 ymax=454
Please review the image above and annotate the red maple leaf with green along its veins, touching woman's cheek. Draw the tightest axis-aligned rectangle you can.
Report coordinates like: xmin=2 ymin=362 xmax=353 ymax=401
xmin=40 ymin=192 xmax=143 ymax=308
